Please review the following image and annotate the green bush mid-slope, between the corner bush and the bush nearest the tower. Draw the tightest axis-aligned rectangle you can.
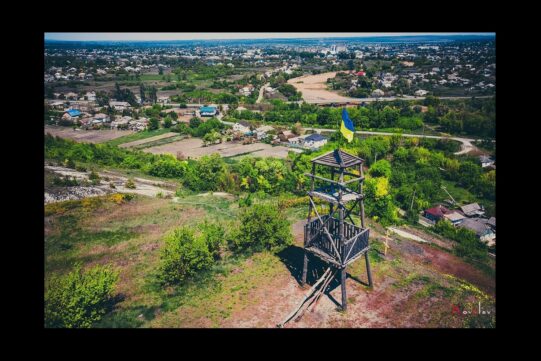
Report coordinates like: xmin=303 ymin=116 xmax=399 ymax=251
xmin=159 ymin=227 xmax=213 ymax=284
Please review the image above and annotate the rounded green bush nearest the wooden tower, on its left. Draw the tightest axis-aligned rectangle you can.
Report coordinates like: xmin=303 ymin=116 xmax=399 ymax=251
xmin=231 ymin=204 xmax=293 ymax=251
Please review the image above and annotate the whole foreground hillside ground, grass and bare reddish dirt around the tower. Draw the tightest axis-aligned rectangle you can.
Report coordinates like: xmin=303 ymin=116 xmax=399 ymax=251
xmin=45 ymin=194 xmax=495 ymax=328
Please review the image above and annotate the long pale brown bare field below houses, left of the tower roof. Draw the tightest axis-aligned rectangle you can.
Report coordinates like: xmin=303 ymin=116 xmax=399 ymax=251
xmin=144 ymin=138 xmax=302 ymax=159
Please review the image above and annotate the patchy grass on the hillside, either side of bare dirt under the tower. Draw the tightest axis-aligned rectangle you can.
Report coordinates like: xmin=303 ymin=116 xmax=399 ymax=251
xmin=45 ymin=167 xmax=494 ymax=327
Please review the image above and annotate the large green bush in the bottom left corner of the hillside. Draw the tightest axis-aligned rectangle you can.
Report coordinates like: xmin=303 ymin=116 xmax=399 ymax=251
xmin=45 ymin=265 xmax=118 ymax=328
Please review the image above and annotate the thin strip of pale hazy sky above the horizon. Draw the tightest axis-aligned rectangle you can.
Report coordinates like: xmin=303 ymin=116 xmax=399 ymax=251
xmin=45 ymin=33 xmax=495 ymax=41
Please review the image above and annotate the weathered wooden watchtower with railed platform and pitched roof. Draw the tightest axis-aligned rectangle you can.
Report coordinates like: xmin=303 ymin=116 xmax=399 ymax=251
xmin=302 ymin=149 xmax=372 ymax=310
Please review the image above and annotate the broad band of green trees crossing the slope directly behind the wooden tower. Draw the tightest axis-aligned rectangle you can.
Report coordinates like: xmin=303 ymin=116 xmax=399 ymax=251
xmin=45 ymin=129 xmax=496 ymax=224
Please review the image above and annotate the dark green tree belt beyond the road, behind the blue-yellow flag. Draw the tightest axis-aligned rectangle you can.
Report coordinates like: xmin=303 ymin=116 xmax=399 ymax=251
xmin=228 ymin=97 xmax=496 ymax=138
